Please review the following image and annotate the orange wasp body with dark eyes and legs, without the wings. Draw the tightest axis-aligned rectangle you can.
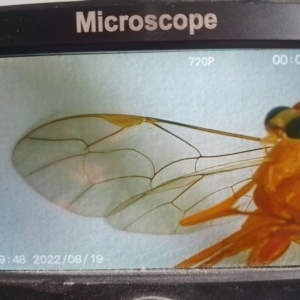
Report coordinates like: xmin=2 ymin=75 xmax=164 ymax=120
xmin=176 ymin=104 xmax=300 ymax=268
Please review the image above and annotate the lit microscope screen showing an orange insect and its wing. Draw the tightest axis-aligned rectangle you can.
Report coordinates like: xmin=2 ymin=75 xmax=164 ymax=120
xmin=0 ymin=49 xmax=300 ymax=270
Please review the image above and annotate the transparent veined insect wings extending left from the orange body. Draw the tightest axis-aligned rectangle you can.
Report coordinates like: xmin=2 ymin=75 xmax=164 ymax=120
xmin=13 ymin=115 xmax=264 ymax=234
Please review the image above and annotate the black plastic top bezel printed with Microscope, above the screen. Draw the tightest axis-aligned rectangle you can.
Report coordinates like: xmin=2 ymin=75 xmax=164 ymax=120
xmin=0 ymin=0 xmax=300 ymax=56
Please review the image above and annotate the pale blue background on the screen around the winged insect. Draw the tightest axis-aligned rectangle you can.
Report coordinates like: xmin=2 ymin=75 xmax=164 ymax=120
xmin=0 ymin=50 xmax=300 ymax=269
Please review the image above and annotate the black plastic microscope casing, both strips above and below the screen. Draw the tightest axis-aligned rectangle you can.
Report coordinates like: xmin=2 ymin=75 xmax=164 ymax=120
xmin=0 ymin=0 xmax=300 ymax=300
